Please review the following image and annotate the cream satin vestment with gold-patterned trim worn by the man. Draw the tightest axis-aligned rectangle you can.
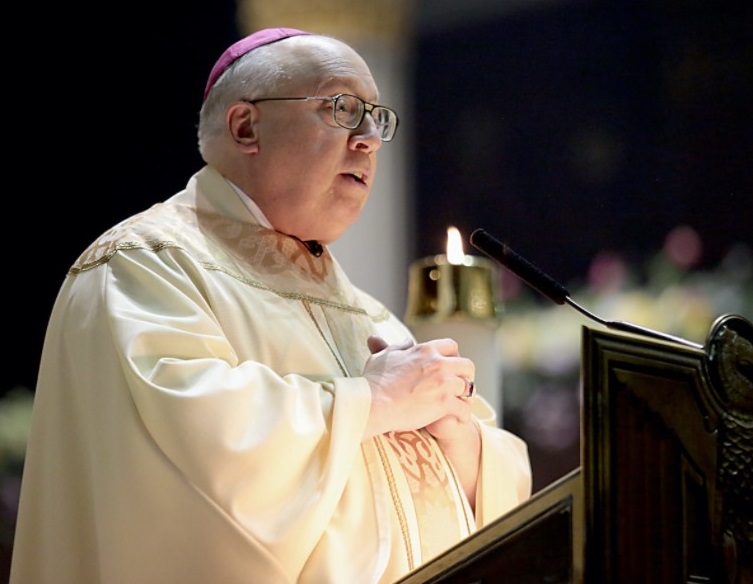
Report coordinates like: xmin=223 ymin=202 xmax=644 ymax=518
xmin=11 ymin=167 xmax=531 ymax=584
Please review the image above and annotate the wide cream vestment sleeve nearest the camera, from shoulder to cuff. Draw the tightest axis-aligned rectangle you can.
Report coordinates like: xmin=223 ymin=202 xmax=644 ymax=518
xmin=96 ymin=249 xmax=370 ymax=557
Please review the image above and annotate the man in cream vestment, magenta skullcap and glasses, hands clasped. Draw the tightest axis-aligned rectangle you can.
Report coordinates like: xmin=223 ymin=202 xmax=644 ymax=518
xmin=11 ymin=29 xmax=531 ymax=584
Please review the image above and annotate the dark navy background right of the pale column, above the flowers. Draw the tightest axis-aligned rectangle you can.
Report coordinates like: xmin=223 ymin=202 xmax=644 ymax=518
xmin=416 ymin=0 xmax=753 ymax=282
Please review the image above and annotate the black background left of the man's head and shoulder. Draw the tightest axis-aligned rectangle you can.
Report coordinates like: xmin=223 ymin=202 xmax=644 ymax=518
xmin=9 ymin=0 xmax=239 ymax=395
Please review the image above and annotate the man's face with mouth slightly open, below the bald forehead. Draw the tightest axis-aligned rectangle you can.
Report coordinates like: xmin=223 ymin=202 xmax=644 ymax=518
xmin=250 ymin=43 xmax=382 ymax=244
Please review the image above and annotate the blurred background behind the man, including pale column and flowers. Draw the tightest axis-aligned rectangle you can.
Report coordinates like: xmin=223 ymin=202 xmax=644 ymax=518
xmin=0 ymin=0 xmax=753 ymax=581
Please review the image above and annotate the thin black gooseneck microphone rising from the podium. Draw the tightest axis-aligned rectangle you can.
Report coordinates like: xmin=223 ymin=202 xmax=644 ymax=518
xmin=470 ymin=229 xmax=703 ymax=349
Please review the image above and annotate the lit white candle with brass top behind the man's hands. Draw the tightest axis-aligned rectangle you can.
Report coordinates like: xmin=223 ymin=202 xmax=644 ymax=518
xmin=405 ymin=227 xmax=502 ymax=426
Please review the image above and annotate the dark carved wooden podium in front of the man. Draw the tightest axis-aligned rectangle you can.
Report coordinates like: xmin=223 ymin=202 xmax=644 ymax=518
xmin=399 ymin=315 xmax=753 ymax=584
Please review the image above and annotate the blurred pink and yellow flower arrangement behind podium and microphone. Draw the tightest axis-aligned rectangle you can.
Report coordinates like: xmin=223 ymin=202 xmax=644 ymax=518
xmin=498 ymin=226 xmax=753 ymax=489
